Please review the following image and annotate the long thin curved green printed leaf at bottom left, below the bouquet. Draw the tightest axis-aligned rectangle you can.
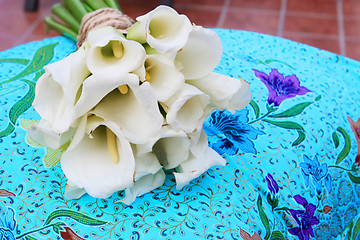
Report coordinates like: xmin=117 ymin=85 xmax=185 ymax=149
xmin=44 ymin=209 xmax=107 ymax=226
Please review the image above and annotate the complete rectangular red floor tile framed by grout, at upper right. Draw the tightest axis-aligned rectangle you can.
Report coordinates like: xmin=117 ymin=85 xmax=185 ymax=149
xmin=284 ymin=15 xmax=338 ymax=35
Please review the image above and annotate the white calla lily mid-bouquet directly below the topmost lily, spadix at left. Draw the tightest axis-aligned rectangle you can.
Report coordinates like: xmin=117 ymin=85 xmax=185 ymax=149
xmin=145 ymin=54 xmax=185 ymax=102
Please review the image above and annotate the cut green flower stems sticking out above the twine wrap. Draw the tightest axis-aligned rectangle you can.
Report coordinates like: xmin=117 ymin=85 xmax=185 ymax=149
xmin=44 ymin=0 xmax=122 ymax=42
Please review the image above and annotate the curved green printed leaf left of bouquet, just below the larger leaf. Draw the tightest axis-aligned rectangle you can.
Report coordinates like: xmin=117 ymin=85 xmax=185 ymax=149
xmin=9 ymin=79 xmax=35 ymax=125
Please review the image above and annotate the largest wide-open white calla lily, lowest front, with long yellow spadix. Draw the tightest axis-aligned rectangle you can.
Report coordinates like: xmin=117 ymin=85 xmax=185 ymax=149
xmin=61 ymin=121 xmax=135 ymax=198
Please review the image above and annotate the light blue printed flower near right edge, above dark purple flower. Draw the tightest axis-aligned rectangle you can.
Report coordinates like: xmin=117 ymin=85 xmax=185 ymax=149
xmin=300 ymin=155 xmax=331 ymax=194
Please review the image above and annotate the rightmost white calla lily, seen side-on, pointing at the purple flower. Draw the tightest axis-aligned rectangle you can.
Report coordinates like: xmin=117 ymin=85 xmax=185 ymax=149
xmin=187 ymin=73 xmax=252 ymax=112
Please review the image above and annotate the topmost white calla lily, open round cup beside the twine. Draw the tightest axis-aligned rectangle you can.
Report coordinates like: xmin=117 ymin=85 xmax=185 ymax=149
xmin=127 ymin=5 xmax=192 ymax=53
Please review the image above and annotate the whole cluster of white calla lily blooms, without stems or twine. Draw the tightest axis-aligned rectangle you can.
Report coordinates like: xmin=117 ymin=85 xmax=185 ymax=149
xmin=29 ymin=3 xmax=251 ymax=204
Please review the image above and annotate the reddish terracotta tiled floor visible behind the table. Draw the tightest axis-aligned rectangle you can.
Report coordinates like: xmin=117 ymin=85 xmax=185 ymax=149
xmin=0 ymin=0 xmax=360 ymax=61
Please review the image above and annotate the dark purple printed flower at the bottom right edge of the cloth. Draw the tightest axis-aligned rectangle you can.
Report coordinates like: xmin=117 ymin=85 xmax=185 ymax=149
xmin=288 ymin=195 xmax=320 ymax=240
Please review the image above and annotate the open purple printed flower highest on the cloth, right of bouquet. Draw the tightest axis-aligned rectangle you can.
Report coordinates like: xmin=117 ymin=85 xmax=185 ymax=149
xmin=253 ymin=69 xmax=311 ymax=106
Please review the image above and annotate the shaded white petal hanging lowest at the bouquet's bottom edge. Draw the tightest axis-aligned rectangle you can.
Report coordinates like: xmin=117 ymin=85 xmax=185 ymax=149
xmin=120 ymin=169 xmax=165 ymax=205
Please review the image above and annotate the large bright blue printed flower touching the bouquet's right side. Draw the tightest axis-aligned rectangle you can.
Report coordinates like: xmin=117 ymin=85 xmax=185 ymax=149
xmin=204 ymin=109 xmax=264 ymax=155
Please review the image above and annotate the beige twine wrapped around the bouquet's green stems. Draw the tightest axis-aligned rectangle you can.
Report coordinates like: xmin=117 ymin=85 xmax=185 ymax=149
xmin=76 ymin=8 xmax=135 ymax=48
